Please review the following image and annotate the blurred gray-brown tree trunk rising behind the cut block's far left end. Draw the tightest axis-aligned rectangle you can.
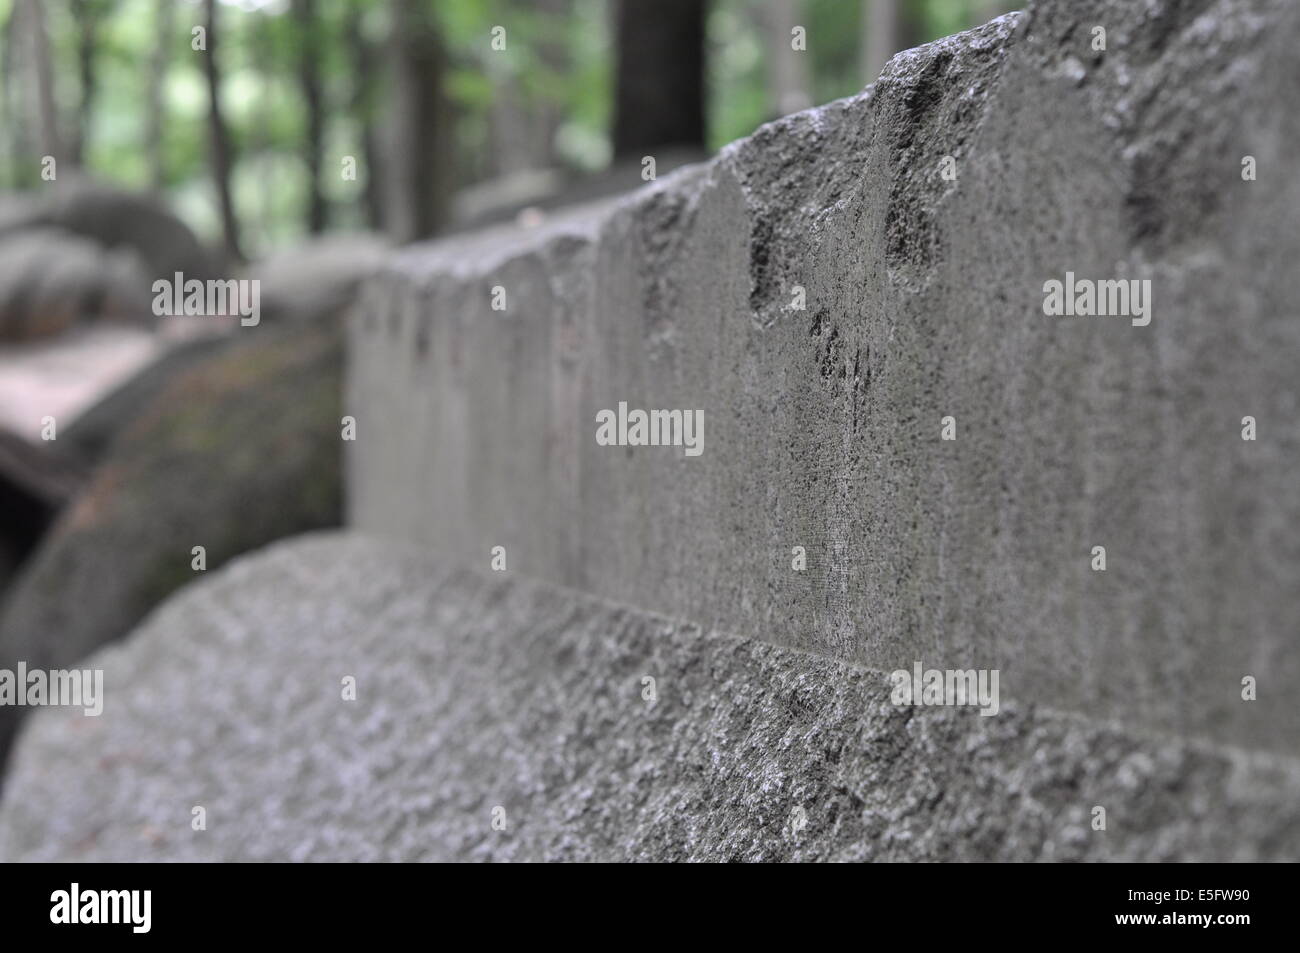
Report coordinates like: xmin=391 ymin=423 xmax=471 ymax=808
xmin=384 ymin=0 xmax=452 ymax=242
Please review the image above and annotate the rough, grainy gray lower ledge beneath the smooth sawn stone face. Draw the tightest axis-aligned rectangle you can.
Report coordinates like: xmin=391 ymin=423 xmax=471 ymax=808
xmin=0 ymin=534 xmax=1300 ymax=861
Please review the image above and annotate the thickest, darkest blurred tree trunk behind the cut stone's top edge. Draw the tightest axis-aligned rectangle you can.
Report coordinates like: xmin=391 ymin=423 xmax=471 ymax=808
xmin=614 ymin=0 xmax=709 ymax=159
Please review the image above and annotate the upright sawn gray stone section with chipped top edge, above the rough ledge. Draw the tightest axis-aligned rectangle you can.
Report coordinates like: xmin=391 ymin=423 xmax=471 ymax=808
xmin=346 ymin=0 xmax=1300 ymax=755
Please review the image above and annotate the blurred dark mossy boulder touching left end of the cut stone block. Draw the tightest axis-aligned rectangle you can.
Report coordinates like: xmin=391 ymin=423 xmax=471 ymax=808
xmin=0 ymin=322 xmax=342 ymax=758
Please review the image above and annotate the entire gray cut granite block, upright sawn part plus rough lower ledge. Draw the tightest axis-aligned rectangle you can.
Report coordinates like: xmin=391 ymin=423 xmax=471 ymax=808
xmin=0 ymin=0 xmax=1300 ymax=861
